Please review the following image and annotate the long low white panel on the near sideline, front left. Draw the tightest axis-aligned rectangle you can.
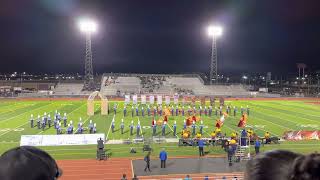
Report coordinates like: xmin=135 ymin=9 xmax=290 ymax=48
xmin=20 ymin=134 xmax=105 ymax=146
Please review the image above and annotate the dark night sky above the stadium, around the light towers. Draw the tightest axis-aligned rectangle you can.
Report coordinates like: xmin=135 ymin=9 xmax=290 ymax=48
xmin=0 ymin=0 xmax=320 ymax=74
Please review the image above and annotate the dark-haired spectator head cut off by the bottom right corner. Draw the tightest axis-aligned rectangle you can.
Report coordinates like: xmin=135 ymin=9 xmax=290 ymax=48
xmin=291 ymin=153 xmax=320 ymax=180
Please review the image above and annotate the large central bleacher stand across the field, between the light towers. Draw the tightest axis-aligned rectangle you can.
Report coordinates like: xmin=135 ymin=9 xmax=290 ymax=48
xmin=100 ymin=74 xmax=250 ymax=97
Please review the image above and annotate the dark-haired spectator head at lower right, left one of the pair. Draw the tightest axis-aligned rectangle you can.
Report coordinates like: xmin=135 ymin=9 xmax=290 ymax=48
xmin=244 ymin=150 xmax=302 ymax=180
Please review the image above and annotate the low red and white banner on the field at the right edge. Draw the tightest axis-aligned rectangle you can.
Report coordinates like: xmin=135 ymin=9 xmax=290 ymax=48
xmin=283 ymin=131 xmax=320 ymax=140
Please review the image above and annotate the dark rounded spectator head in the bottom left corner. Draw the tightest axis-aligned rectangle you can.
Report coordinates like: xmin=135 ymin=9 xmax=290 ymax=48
xmin=0 ymin=146 xmax=62 ymax=180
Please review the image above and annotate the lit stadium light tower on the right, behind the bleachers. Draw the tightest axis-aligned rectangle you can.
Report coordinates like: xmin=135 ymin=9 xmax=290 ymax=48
xmin=208 ymin=26 xmax=222 ymax=84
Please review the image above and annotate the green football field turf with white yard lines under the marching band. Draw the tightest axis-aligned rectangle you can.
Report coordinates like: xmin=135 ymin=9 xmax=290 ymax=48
xmin=0 ymin=100 xmax=320 ymax=159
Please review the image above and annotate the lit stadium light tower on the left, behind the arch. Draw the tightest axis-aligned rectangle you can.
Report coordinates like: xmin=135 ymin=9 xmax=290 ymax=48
xmin=78 ymin=19 xmax=97 ymax=91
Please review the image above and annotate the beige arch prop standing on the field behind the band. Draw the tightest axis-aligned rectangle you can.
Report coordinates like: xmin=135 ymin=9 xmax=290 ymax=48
xmin=87 ymin=91 xmax=108 ymax=116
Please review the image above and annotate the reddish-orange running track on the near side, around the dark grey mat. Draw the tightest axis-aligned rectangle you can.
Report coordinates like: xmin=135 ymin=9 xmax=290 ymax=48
xmin=58 ymin=157 xmax=243 ymax=180
